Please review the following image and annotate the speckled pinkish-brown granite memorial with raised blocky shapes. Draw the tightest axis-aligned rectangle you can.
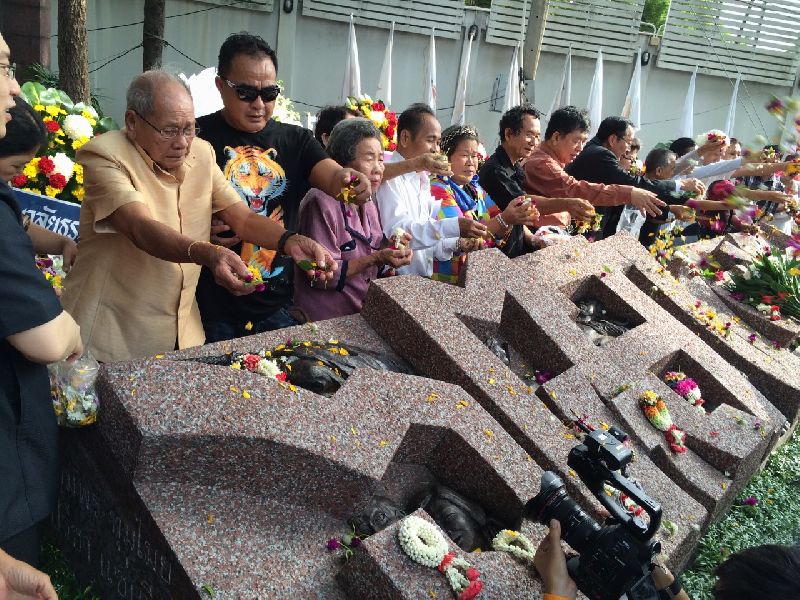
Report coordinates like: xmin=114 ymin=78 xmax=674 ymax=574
xmin=55 ymin=235 xmax=800 ymax=599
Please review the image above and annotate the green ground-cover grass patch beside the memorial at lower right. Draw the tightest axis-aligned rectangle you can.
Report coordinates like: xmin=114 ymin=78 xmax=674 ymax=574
xmin=681 ymin=428 xmax=800 ymax=600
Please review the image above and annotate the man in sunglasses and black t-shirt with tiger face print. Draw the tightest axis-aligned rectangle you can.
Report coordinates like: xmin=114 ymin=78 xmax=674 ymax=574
xmin=197 ymin=32 xmax=371 ymax=342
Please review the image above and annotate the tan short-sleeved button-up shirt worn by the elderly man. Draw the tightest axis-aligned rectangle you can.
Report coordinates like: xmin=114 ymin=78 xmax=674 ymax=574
xmin=62 ymin=131 xmax=240 ymax=361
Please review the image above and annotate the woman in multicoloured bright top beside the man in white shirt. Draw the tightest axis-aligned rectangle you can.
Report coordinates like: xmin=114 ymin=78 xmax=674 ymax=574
xmin=431 ymin=125 xmax=539 ymax=284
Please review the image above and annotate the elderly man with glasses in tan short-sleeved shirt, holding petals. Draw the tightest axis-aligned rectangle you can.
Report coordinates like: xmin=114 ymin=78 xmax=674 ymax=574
xmin=62 ymin=71 xmax=335 ymax=361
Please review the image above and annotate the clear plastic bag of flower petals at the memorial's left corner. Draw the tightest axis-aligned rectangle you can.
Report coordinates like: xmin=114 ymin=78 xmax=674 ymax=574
xmin=49 ymin=352 xmax=100 ymax=427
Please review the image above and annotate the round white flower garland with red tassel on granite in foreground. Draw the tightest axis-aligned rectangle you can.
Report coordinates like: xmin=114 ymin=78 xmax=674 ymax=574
xmin=397 ymin=515 xmax=483 ymax=600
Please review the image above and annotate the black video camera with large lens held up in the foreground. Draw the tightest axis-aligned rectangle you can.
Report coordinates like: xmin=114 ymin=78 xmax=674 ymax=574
xmin=525 ymin=420 xmax=661 ymax=600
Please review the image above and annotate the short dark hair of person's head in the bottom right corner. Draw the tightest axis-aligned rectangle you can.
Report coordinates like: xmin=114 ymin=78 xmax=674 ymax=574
xmin=714 ymin=544 xmax=800 ymax=600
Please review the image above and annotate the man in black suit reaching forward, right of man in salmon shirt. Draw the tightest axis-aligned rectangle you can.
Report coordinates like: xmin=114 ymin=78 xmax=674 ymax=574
xmin=566 ymin=117 xmax=705 ymax=238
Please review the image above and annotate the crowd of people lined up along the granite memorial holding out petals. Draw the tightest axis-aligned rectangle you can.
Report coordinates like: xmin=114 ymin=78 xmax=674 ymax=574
xmin=0 ymin=25 xmax=795 ymax=598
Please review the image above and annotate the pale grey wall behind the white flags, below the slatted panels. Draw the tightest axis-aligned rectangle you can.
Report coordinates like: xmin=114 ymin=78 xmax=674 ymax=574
xmin=52 ymin=0 xmax=791 ymax=156
